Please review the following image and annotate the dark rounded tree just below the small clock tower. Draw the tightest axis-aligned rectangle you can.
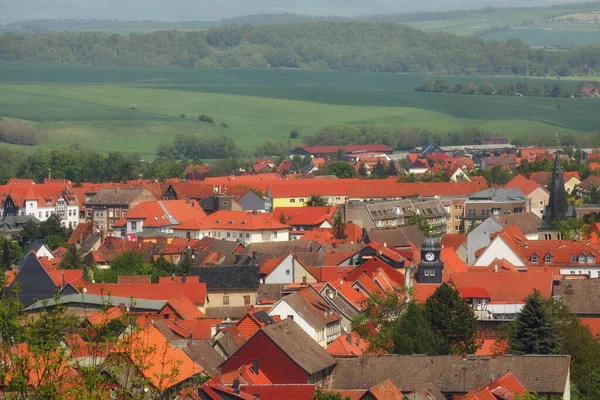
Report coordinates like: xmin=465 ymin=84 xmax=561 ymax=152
xmin=425 ymin=283 xmax=478 ymax=354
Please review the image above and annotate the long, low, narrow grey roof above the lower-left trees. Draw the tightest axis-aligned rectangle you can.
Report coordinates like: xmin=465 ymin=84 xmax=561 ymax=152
xmin=25 ymin=293 xmax=167 ymax=311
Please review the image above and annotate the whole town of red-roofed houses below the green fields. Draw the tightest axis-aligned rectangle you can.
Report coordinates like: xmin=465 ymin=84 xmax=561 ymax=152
xmin=0 ymin=137 xmax=600 ymax=400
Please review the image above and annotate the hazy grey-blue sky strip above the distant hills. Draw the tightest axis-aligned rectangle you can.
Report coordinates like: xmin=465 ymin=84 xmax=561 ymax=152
xmin=0 ymin=0 xmax=582 ymax=21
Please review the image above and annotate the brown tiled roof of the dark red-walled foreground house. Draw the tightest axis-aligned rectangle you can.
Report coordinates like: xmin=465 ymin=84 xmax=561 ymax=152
xmin=260 ymin=318 xmax=335 ymax=375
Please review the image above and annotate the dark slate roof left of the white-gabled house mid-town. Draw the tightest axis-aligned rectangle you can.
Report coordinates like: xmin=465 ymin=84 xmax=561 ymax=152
xmin=190 ymin=265 xmax=260 ymax=292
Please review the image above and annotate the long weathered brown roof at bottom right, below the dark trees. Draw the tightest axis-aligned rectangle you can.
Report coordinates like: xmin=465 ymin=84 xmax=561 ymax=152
xmin=330 ymin=355 xmax=571 ymax=394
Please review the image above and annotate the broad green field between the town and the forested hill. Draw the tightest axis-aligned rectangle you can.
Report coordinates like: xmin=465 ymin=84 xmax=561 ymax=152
xmin=0 ymin=63 xmax=600 ymax=157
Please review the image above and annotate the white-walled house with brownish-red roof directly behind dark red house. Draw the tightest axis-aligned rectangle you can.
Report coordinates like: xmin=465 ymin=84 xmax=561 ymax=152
xmin=269 ymin=286 xmax=342 ymax=348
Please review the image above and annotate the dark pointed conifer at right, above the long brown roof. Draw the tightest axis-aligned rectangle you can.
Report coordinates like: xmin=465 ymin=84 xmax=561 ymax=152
xmin=510 ymin=290 xmax=559 ymax=354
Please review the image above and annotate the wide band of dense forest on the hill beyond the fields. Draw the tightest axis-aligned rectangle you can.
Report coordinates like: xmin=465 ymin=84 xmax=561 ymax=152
xmin=0 ymin=22 xmax=600 ymax=76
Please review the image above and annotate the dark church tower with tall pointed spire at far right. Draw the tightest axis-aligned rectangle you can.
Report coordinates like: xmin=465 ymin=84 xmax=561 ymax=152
xmin=538 ymin=149 xmax=576 ymax=240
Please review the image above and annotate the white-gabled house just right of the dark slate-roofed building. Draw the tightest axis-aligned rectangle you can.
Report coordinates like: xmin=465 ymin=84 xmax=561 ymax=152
xmin=260 ymin=251 xmax=317 ymax=283
